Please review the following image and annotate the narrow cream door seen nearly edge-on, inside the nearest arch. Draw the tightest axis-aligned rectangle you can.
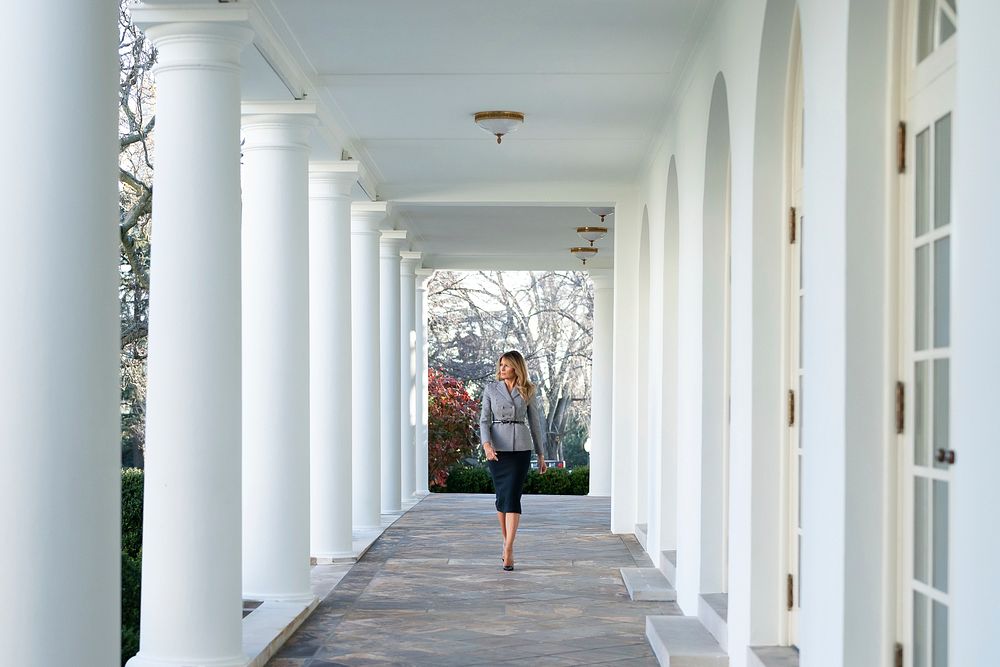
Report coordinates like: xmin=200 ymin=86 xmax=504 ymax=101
xmin=784 ymin=30 xmax=806 ymax=646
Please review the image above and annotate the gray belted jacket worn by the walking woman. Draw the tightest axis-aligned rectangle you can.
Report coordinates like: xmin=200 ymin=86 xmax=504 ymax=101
xmin=479 ymin=380 xmax=545 ymax=456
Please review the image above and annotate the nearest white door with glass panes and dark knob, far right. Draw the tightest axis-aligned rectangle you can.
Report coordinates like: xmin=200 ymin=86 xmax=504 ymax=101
xmin=900 ymin=0 xmax=958 ymax=667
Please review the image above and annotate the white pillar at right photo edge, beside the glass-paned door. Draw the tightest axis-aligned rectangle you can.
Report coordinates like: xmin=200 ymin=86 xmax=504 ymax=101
xmin=948 ymin=0 xmax=1000 ymax=665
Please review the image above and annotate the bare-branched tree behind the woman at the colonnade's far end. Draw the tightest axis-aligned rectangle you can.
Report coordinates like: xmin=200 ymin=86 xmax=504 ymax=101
xmin=428 ymin=271 xmax=594 ymax=458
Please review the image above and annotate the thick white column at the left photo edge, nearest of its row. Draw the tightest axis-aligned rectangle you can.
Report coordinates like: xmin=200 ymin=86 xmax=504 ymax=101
xmin=0 ymin=0 xmax=121 ymax=665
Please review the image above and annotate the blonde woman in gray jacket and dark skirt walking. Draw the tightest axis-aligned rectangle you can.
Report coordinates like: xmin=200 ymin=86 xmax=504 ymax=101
xmin=479 ymin=350 xmax=545 ymax=571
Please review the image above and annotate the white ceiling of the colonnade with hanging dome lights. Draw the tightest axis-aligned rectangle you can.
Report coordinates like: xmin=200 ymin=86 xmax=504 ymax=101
xmin=233 ymin=0 xmax=713 ymax=268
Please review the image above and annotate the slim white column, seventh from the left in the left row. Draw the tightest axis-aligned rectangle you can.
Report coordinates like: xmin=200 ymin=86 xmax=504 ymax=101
xmin=399 ymin=250 xmax=421 ymax=500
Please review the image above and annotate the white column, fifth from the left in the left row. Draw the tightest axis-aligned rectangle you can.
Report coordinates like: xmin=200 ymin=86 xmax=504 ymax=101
xmin=351 ymin=202 xmax=386 ymax=530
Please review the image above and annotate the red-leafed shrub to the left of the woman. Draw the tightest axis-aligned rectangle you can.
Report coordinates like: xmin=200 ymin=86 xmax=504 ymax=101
xmin=427 ymin=368 xmax=479 ymax=487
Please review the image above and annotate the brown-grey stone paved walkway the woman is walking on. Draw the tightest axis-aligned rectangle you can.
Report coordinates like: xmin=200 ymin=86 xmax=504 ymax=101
xmin=268 ymin=494 xmax=680 ymax=667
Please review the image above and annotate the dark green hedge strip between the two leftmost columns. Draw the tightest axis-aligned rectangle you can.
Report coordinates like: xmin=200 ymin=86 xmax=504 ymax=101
xmin=122 ymin=468 xmax=143 ymax=665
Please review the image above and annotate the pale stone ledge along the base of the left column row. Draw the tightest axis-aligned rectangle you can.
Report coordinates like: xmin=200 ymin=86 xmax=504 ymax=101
xmin=243 ymin=498 xmax=421 ymax=667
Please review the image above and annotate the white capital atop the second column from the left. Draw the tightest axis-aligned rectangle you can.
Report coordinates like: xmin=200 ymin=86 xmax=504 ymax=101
xmin=132 ymin=4 xmax=254 ymax=73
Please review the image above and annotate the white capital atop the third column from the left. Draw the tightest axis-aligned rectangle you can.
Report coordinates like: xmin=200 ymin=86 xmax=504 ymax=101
xmin=241 ymin=101 xmax=319 ymax=153
